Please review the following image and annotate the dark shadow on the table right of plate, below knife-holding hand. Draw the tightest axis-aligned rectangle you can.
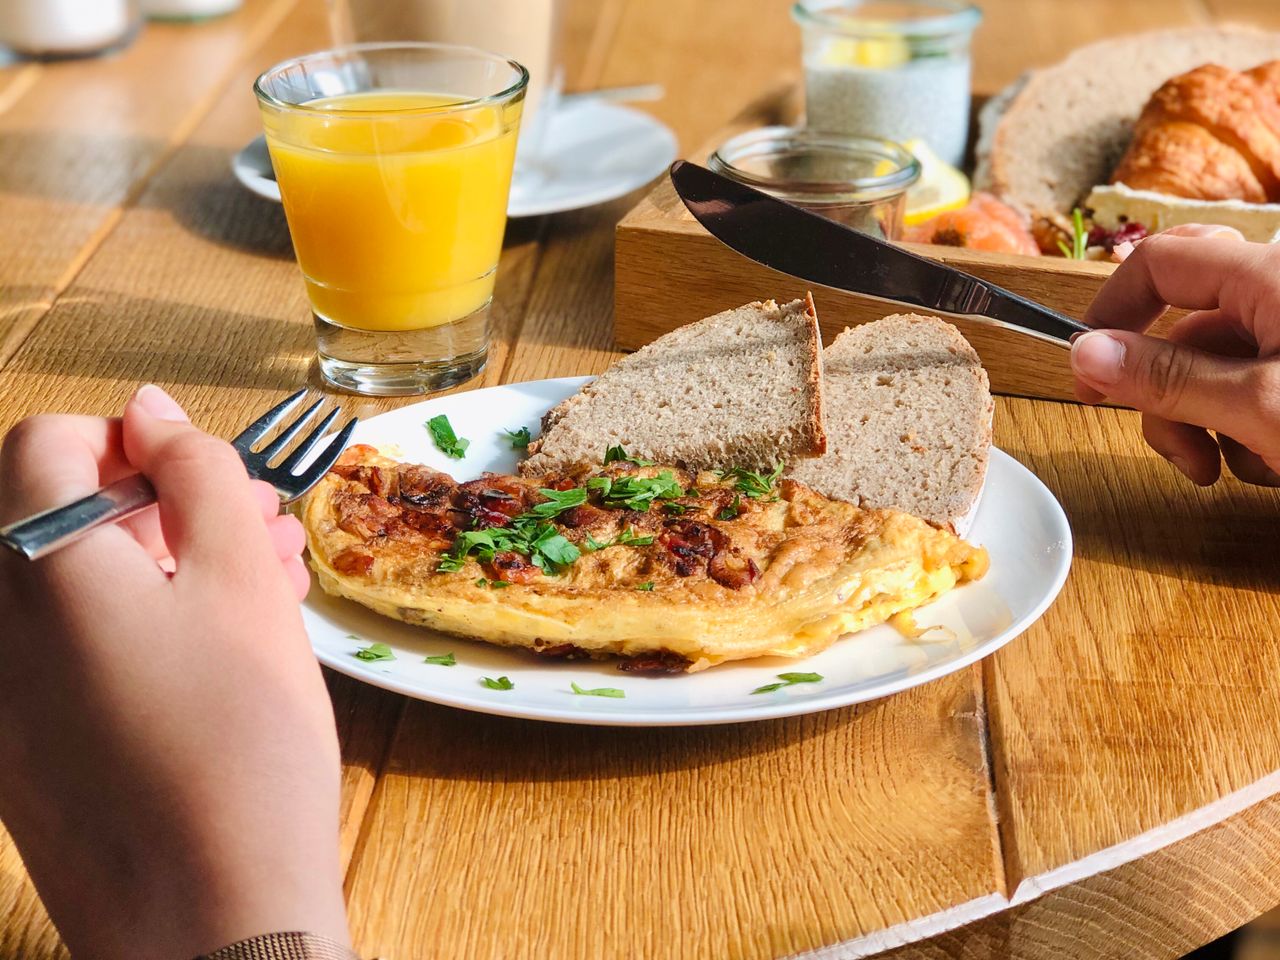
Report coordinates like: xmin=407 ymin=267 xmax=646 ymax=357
xmin=1009 ymin=449 xmax=1280 ymax=590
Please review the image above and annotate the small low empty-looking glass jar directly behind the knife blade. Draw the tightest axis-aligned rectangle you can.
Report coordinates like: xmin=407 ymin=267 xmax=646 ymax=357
xmin=708 ymin=127 xmax=920 ymax=239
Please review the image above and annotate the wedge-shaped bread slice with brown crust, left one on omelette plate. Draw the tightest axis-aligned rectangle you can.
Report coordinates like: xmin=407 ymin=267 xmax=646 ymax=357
xmin=520 ymin=297 xmax=827 ymax=475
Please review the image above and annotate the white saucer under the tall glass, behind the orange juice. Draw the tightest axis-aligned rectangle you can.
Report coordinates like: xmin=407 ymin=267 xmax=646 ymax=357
xmin=232 ymin=100 xmax=676 ymax=216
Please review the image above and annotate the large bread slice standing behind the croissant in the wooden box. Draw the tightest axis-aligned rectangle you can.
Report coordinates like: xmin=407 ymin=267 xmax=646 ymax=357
xmin=974 ymin=26 xmax=1280 ymax=230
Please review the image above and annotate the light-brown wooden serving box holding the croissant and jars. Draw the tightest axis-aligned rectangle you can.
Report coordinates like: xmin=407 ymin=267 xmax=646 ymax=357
xmin=613 ymin=83 xmax=1176 ymax=399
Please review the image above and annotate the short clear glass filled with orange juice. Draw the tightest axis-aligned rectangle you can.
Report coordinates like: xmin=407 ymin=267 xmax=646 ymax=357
xmin=253 ymin=44 xmax=529 ymax=396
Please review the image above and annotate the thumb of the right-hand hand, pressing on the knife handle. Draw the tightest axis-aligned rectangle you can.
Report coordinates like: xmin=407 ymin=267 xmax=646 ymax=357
xmin=1071 ymin=330 xmax=1260 ymax=443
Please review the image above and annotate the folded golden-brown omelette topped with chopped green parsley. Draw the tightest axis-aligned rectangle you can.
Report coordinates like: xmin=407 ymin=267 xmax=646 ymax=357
xmin=302 ymin=445 xmax=987 ymax=673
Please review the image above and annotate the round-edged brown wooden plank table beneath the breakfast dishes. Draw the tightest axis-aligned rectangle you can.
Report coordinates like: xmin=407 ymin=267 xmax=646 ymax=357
xmin=0 ymin=0 xmax=1280 ymax=960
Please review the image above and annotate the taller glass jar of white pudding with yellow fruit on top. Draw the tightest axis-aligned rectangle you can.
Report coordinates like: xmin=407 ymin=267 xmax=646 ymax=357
xmin=791 ymin=0 xmax=982 ymax=166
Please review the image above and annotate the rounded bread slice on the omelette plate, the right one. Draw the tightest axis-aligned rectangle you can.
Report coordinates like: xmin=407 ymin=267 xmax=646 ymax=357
xmin=788 ymin=314 xmax=992 ymax=529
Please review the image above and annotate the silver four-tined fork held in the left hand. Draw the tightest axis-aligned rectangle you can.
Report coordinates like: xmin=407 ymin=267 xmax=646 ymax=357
xmin=0 ymin=387 xmax=358 ymax=559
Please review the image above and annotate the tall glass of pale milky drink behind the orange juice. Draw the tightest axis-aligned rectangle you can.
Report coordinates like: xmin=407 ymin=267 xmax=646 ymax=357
xmin=329 ymin=0 xmax=563 ymax=178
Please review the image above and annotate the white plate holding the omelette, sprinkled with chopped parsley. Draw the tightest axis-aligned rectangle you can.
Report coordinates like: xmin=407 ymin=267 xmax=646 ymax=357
xmin=302 ymin=378 xmax=1071 ymax=726
